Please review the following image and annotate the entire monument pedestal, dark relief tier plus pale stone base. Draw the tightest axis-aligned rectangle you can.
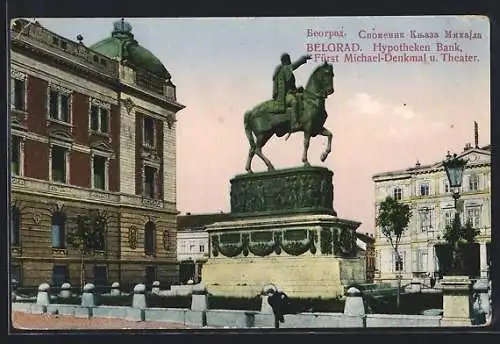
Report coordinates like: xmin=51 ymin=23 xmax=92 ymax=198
xmin=202 ymin=167 xmax=366 ymax=298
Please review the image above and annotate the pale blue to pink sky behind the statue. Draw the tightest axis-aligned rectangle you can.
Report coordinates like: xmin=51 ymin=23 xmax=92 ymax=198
xmin=33 ymin=16 xmax=490 ymax=233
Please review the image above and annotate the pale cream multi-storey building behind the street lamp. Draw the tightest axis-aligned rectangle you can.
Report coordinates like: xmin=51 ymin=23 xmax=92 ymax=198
xmin=373 ymin=140 xmax=491 ymax=281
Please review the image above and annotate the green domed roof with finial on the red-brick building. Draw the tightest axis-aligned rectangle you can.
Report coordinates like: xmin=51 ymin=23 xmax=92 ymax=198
xmin=90 ymin=19 xmax=170 ymax=79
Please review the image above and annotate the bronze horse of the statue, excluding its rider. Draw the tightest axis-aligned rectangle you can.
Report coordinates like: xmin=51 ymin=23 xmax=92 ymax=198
xmin=244 ymin=62 xmax=334 ymax=173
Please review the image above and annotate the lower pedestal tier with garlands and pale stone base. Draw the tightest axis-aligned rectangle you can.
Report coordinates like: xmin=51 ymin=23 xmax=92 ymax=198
xmin=202 ymin=215 xmax=366 ymax=298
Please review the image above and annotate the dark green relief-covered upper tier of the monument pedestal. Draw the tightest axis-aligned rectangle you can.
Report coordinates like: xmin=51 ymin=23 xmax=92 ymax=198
xmin=231 ymin=167 xmax=336 ymax=215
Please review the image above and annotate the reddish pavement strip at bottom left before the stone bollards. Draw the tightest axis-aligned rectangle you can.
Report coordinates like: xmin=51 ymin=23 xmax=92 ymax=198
xmin=12 ymin=312 xmax=196 ymax=330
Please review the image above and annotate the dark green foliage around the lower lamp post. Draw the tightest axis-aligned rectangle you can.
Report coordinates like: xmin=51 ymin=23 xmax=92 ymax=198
xmin=443 ymin=211 xmax=480 ymax=275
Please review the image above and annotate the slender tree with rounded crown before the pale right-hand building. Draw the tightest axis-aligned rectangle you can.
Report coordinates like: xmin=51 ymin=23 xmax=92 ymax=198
xmin=376 ymin=196 xmax=412 ymax=309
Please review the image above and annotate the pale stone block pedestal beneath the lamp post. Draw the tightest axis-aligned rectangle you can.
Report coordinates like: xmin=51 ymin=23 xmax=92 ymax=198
xmin=441 ymin=276 xmax=472 ymax=326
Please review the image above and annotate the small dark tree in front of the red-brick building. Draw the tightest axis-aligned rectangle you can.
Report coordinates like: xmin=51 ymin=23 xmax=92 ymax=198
xmin=68 ymin=210 xmax=107 ymax=288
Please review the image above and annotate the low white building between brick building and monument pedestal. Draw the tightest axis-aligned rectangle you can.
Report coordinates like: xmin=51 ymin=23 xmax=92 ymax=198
xmin=177 ymin=213 xmax=229 ymax=283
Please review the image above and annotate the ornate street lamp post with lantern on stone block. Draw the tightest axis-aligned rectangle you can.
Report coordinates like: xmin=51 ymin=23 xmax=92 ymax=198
xmin=443 ymin=153 xmax=467 ymax=273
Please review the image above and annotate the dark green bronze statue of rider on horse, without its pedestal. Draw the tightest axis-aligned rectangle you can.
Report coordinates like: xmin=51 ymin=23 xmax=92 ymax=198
xmin=244 ymin=53 xmax=334 ymax=173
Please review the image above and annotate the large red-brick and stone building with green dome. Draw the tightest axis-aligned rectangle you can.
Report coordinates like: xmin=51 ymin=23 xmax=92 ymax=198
xmin=10 ymin=19 xmax=184 ymax=286
